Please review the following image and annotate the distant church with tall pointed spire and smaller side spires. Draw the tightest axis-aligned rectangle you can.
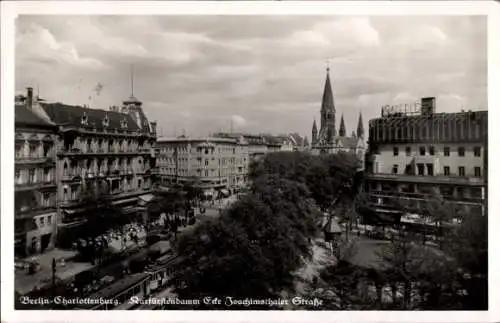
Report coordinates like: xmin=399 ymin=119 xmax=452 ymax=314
xmin=311 ymin=69 xmax=366 ymax=160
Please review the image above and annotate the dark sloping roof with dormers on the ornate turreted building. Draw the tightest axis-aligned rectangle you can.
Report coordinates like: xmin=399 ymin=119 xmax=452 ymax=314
xmin=41 ymin=103 xmax=149 ymax=131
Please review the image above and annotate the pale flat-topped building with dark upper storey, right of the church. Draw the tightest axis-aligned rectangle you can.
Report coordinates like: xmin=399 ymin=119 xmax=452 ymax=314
xmin=366 ymin=98 xmax=488 ymax=218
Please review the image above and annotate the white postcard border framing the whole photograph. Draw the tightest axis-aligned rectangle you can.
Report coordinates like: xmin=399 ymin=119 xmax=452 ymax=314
xmin=0 ymin=1 xmax=500 ymax=322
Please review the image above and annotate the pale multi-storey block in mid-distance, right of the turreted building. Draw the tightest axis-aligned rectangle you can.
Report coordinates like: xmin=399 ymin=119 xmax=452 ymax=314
xmin=156 ymin=136 xmax=249 ymax=199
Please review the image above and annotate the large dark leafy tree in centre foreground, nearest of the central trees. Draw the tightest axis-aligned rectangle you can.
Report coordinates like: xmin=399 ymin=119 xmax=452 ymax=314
xmin=170 ymin=178 xmax=317 ymax=306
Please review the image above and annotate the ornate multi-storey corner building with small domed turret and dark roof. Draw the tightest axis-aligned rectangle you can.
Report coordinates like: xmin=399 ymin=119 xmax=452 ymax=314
xmin=16 ymin=90 xmax=156 ymax=247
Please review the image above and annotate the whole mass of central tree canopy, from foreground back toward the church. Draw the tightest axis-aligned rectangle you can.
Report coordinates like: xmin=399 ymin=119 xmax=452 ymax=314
xmin=168 ymin=152 xmax=356 ymax=308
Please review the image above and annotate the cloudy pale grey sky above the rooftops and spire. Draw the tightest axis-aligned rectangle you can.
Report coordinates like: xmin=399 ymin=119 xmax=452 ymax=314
xmin=15 ymin=15 xmax=487 ymax=139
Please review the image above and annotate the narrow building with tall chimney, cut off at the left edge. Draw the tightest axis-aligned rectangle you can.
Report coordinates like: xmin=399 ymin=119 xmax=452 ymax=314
xmin=14 ymin=88 xmax=57 ymax=257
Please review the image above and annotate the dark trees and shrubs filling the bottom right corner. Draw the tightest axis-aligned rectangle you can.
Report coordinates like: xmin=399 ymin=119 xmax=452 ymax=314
xmin=318 ymin=198 xmax=488 ymax=310
